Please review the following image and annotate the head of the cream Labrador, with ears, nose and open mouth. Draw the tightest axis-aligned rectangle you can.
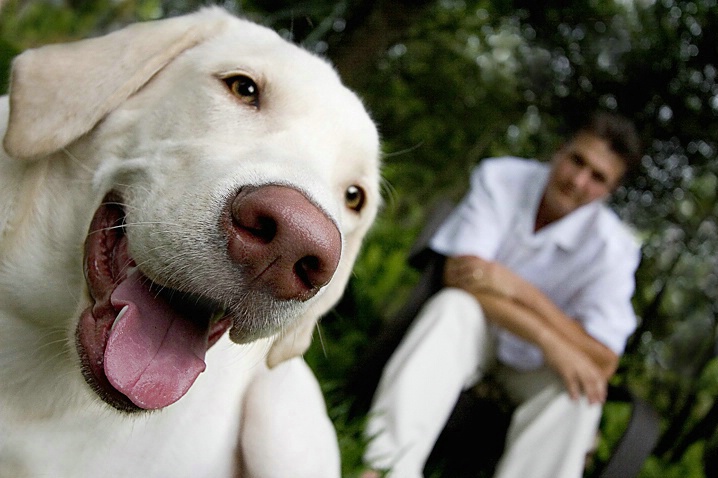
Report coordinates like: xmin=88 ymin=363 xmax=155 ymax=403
xmin=4 ymin=9 xmax=379 ymax=411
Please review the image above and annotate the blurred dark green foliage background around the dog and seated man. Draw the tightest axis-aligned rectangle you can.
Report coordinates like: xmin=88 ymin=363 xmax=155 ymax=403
xmin=0 ymin=0 xmax=718 ymax=478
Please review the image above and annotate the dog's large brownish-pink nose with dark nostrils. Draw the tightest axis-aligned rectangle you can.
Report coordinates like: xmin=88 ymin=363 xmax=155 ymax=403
xmin=229 ymin=185 xmax=342 ymax=301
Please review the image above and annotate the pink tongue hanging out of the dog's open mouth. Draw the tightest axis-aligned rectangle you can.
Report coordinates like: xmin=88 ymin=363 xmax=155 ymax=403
xmin=105 ymin=273 xmax=208 ymax=409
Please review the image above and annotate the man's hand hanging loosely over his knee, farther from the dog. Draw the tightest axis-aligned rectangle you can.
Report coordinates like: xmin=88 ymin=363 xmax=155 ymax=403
xmin=540 ymin=332 xmax=608 ymax=403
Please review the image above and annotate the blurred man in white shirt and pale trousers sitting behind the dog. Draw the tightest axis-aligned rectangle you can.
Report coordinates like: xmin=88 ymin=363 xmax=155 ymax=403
xmin=362 ymin=112 xmax=641 ymax=478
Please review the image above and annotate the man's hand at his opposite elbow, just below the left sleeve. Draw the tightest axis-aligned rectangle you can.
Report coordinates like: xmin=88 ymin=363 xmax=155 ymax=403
xmin=444 ymin=256 xmax=523 ymax=298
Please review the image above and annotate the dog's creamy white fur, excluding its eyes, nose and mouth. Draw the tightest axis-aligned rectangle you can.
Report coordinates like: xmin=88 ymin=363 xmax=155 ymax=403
xmin=0 ymin=9 xmax=379 ymax=478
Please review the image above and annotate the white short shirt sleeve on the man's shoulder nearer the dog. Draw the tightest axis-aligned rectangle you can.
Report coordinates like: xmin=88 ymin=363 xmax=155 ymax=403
xmin=429 ymin=160 xmax=507 ymax=260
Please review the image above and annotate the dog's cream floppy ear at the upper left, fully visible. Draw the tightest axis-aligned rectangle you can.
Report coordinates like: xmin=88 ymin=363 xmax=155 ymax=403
xmin=4 ymin=8 xmax=229 ymax=158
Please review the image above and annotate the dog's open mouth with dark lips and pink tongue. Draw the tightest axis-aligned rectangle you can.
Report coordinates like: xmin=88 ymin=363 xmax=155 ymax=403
xmin=76 ymin=194 xmax=231 ymax=411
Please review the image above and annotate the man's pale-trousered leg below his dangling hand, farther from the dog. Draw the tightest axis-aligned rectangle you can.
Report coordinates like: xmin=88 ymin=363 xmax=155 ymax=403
xmin=494 ymin=367 xmax=602 ymax=478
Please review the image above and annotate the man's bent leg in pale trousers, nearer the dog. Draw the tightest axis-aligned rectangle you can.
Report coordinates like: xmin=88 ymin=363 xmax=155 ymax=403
xmin=364 ymin=289 xmax=493 ymax=478
